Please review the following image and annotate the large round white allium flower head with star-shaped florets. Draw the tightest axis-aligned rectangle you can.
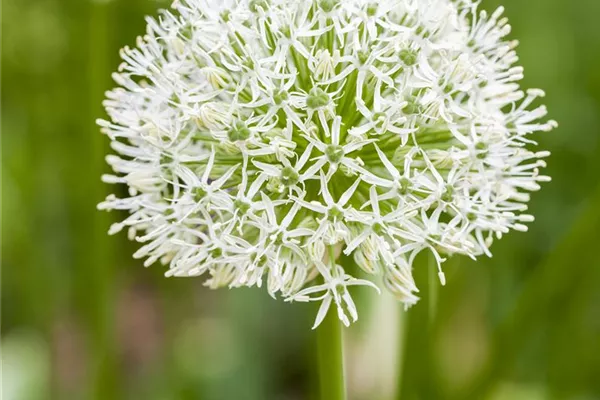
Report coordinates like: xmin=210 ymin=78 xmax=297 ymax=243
xmin=99 ymin=0 xmax=556 ymax=325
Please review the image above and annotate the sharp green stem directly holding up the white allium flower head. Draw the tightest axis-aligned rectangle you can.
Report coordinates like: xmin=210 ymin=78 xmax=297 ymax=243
xmin=317 ymin=249 xmax=346 ymax=400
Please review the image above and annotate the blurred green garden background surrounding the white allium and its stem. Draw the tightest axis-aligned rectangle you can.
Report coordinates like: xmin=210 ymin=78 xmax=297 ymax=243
xmin=0 ymin=0 xmax=600 ymax=400
